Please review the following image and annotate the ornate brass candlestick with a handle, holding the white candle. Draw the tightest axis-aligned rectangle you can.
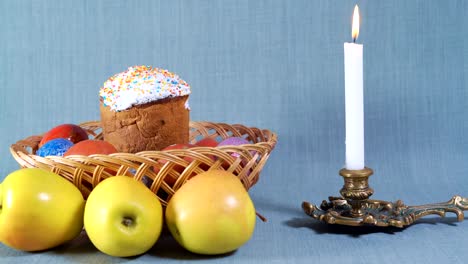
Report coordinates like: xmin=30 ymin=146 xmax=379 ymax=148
xmin=302 ymin=168 xmax=468 ymax=227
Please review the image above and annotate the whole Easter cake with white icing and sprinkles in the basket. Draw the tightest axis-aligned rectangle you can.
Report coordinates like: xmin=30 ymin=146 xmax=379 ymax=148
xmin=99 ymin=66 xmax=191 ymax=153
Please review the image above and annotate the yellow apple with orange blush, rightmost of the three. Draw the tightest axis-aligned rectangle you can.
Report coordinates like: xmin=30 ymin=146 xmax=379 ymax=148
xmin=166 ymin=170 xmax=255 ymax=255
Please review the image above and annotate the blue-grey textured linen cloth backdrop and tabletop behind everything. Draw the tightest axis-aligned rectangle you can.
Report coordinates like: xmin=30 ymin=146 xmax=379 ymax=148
xmin=0 ymin=0 xmax=468 ymax=264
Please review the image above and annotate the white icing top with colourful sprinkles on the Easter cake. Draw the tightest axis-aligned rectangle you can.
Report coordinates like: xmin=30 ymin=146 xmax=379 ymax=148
xmin=99 ymin=66 xmax=190 ymax=111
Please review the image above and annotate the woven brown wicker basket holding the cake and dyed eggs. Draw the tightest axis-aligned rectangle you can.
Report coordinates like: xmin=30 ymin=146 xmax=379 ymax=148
xmin=10 ymin=121 xmax=277 ymax=206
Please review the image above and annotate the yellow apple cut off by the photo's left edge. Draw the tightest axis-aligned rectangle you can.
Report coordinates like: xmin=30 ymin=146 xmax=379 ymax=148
xmin=0 ymin=168 xmax=85 ymax=251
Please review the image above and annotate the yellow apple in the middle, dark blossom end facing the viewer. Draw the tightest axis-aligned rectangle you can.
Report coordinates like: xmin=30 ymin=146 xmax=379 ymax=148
xmin=84 ymin=176 xmax=163 ymax=257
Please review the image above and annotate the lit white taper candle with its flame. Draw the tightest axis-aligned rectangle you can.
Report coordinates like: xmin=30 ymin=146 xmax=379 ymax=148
xmin=344 ymin=5 xmax=364 ymax=170
